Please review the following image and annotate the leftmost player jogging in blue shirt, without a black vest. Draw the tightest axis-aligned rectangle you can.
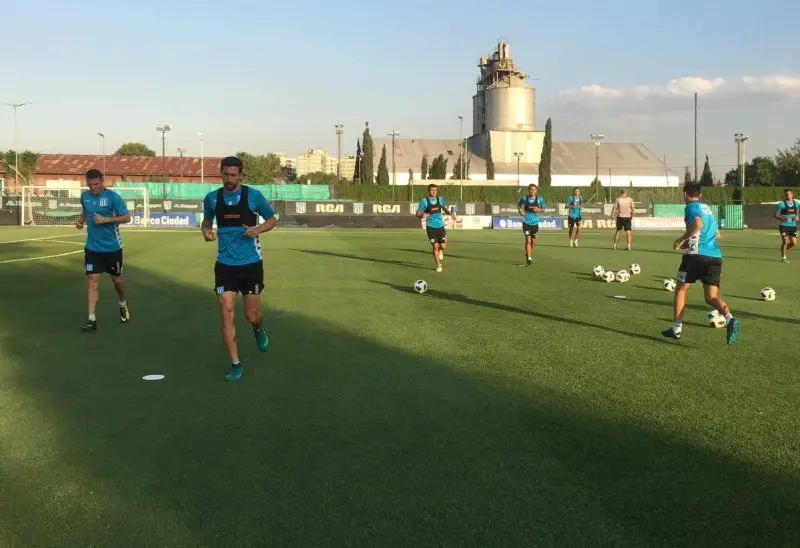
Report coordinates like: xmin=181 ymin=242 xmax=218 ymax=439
xmin=75 ymin=169 xmax=131 ymax=333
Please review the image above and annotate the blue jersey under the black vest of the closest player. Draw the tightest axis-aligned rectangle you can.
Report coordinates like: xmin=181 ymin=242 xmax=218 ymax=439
xmin=203 ymin=186 xmax=275 ymax=266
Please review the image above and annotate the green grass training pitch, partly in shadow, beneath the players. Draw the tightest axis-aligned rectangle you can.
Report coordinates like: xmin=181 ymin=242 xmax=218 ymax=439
xmin=0 ymin=228 xmax=800 ymax=547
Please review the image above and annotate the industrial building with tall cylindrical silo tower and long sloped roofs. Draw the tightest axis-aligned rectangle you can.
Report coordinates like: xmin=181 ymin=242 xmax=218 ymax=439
xmin=373 ymin=42 xmax=679 ymax=187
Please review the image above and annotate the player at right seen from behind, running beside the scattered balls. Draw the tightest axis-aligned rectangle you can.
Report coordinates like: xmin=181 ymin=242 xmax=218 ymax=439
xmin=661 ymin=184 xmax=739 ymax=344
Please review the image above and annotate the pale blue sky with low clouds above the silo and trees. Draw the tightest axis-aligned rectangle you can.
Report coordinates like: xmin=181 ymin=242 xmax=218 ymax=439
xmin=0 ymin=0 xmax=800 ymax=176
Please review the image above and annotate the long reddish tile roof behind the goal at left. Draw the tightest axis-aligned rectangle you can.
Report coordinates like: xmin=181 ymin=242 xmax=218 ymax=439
xmin=0 ymin=154 xmax=222 ymax=177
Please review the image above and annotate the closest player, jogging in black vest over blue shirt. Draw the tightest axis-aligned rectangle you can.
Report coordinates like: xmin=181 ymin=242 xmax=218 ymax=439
xmin=201 ymin=156 xmax=278 ymax=381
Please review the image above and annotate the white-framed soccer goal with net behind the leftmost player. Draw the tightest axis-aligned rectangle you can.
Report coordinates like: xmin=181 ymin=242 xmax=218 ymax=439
xmin=19 ymin=185 xmax=150 ymax=227
